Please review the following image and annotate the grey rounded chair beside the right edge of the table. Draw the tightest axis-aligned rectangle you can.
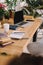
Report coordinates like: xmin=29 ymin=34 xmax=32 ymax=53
xmin=23 ymin=38 xmax=43 ymax=56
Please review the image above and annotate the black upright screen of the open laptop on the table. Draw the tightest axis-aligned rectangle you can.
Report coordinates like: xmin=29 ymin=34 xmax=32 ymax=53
xmin=14 ymin=10 xmax=24 ymax=24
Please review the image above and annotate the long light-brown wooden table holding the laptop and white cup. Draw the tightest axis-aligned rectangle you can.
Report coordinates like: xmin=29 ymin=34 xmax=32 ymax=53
xmin=0 ymin=16 xmax=41 ymax=65
